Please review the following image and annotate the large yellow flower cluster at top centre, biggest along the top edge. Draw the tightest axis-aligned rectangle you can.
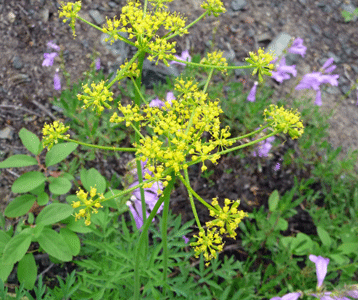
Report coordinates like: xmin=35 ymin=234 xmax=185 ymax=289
xmin=102 ymin=0 xmax=189 ymax=65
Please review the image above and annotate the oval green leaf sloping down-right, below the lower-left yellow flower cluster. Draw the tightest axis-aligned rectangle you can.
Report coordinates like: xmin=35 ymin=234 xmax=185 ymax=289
xmin=38 ymin=228 xmax=72 ymax=261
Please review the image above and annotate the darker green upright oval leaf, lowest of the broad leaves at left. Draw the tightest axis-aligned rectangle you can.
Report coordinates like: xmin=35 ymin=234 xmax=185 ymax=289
xmin=17 ymin=253 xmax=37 ymax=290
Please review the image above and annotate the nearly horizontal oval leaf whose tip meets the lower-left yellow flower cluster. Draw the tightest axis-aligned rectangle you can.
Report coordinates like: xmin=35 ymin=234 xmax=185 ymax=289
xmin=36 ymin=203 xmax=73 ymax=225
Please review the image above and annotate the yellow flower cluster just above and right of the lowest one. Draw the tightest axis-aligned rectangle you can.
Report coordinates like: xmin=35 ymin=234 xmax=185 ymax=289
xmin=206 ymin=198 xmax=248 ymax=239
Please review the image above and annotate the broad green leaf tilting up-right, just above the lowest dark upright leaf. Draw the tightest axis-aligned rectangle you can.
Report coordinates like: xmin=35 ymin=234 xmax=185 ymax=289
xmin=3 ymin=231 xmax=31 ymax=265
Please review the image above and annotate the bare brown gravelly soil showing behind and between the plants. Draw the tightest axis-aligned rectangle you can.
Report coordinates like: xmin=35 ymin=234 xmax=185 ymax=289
xmin=0 ymin=0 xmax=358 ymax=292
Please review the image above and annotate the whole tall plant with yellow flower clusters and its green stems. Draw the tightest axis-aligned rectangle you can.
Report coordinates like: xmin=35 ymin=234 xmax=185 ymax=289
xmin=43 ymin=0 xmax=304 ymax=299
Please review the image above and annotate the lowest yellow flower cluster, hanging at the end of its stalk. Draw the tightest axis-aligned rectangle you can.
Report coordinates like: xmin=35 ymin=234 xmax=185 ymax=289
xmin=190 ymin=228 xmax=224 ymax=266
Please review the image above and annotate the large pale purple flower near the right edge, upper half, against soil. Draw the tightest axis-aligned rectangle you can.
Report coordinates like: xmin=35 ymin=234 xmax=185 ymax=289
xmin=295 ymin=58 xmax=339 ymax=106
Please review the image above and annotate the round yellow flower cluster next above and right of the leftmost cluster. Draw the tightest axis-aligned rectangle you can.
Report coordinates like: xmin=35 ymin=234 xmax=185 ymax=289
xmin=77 ymin=80 xmax=113 ymax=114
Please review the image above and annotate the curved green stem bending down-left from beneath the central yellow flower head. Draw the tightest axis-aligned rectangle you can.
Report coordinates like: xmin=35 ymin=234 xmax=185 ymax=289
xmin=134 ymin=176 xmax=175 ymax=300
